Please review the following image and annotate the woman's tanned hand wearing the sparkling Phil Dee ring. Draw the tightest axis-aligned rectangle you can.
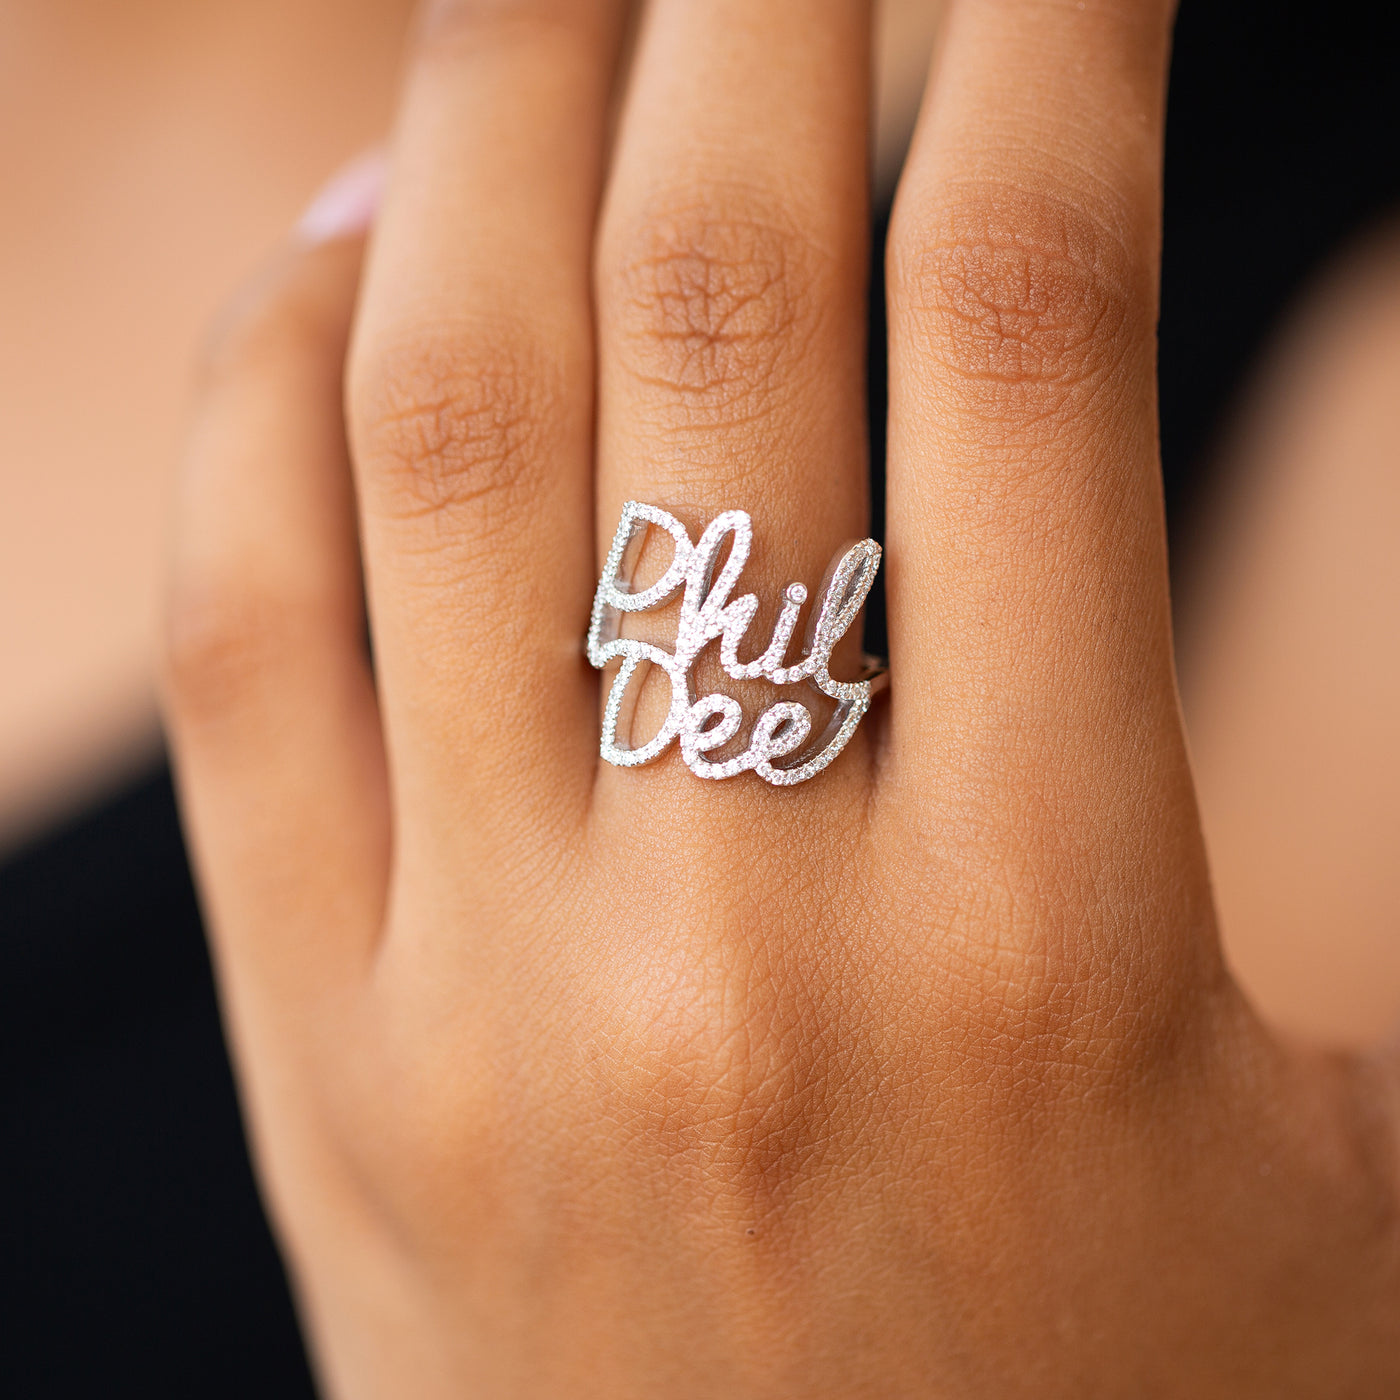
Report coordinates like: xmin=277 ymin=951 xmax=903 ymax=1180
xmin=168 ymin=0 xmax=1400 ymax=1400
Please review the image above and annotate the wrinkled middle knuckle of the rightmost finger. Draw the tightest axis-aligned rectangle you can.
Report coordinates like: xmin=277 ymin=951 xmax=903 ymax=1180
xmin=890 ymin=190 xmax=1141 ymax=426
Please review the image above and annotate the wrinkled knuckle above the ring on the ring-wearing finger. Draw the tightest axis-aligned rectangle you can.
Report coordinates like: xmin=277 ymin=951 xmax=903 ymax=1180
xmin=603 ymin=196 xmax=830 ymax=407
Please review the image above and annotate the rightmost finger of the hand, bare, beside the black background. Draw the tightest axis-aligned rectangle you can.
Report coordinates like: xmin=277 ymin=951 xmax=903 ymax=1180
xmin=886 ymin=0 xmax=1211 ymax=952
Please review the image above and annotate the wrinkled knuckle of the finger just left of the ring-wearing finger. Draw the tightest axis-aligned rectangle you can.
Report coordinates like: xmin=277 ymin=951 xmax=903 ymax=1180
xmin=351 ymin=333 xmax=564 ymax=529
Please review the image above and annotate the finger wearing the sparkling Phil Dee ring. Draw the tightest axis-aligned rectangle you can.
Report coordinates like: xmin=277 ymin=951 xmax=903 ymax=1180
xmin=598 ymin=0 xmax=871 ymax=802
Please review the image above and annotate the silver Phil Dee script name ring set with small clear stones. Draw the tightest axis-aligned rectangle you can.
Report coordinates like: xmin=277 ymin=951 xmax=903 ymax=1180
xmin=588 ymin=501 xmax=886 ymax=787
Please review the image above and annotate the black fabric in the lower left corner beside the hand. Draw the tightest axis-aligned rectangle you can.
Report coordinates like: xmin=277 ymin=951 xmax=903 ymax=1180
xmin=0 ymin=773 xmax=314 ymax=1400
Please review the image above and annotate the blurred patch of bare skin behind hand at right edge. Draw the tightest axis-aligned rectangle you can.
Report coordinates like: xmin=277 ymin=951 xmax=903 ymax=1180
xmin=1182 ymin=218 xmax=1400 ymax=1046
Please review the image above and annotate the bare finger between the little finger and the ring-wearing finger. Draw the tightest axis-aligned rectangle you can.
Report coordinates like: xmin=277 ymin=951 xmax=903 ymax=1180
xmin=350 ymin=0 xmax=622 ymax=851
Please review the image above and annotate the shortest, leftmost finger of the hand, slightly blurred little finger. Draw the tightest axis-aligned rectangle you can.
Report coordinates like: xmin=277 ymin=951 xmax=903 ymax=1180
xmin=165 ymin=221 xmax=388 ymax=1004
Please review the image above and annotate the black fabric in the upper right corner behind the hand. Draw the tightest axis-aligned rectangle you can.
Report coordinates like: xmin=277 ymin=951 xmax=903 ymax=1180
xmin=1159 ymin=0 xmax=1400 ymax=548
